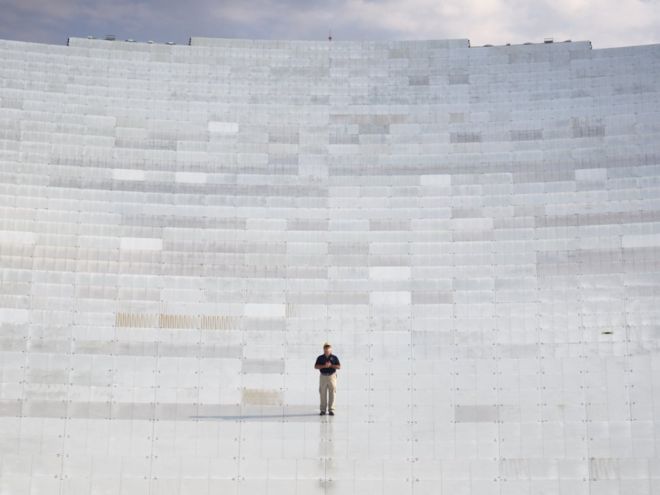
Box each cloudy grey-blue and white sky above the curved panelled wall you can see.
[0,0,660,48]
